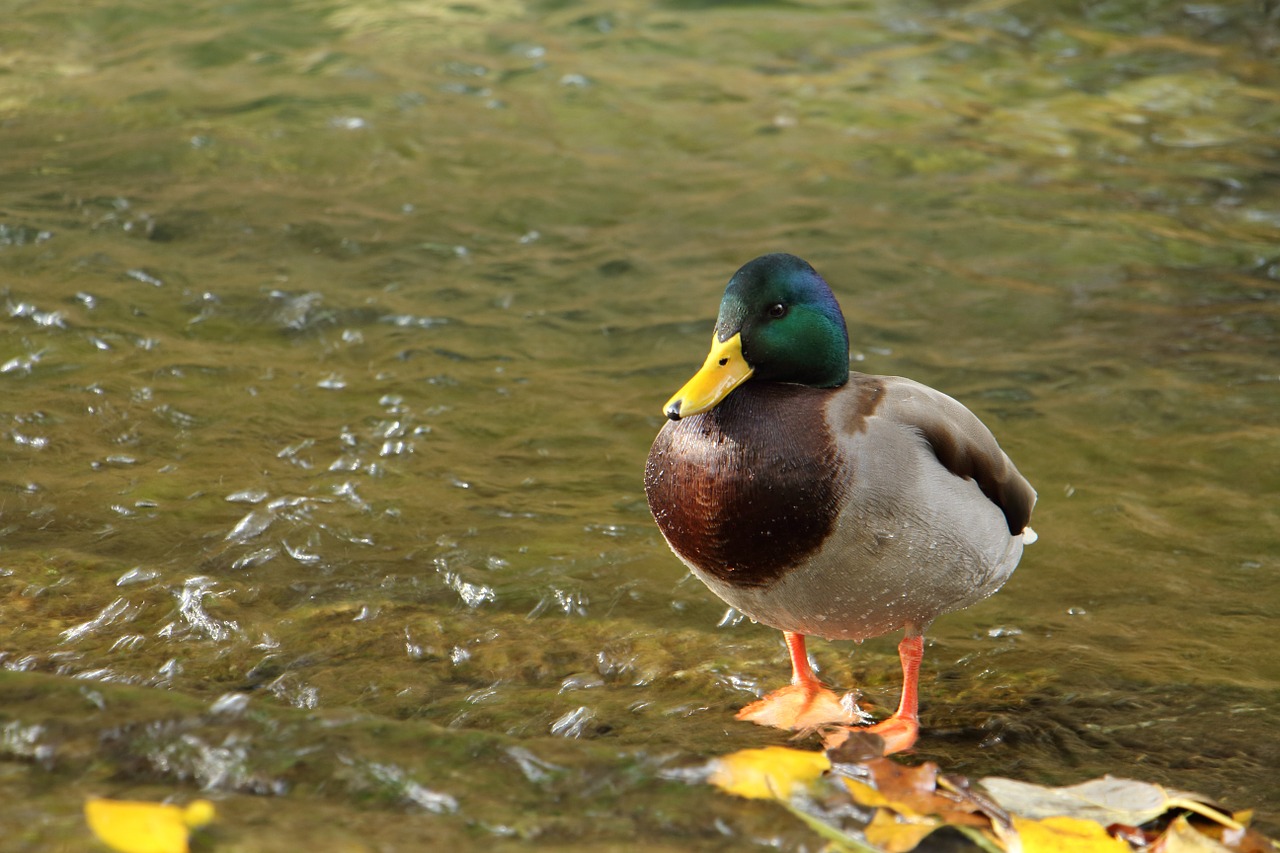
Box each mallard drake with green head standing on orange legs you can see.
[644,254,1036,753]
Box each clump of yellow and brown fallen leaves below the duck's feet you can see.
[707,747,1275,853]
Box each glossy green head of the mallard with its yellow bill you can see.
[663,254,849,420]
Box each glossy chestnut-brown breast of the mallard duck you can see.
[644,384,844,587]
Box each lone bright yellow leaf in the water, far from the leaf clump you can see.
[84,797,214,853]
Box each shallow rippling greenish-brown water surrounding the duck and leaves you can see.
[0,0,1280,850]
